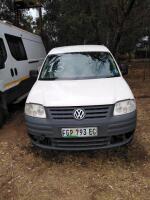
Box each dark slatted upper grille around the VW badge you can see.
[47,105,112,120]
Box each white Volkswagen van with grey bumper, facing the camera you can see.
[25,45,136,150]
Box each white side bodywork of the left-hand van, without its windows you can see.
[0,21,46,103]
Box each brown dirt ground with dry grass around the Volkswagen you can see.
[0,63,150,200]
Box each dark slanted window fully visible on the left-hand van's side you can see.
[5,34,27,61]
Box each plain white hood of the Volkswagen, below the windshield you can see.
[27,77,134,107]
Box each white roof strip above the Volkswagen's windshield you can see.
[49,45,110,55]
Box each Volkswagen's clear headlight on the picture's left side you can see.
[25,103,46,118]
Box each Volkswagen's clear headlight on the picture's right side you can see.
[114,100,136,115]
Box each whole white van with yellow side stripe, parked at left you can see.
[0,21,46,126]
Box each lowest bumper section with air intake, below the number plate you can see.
[30,131,134,151]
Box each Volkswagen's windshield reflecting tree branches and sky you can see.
[39,52,120,80]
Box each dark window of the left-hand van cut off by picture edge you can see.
[0,38,7,69]
